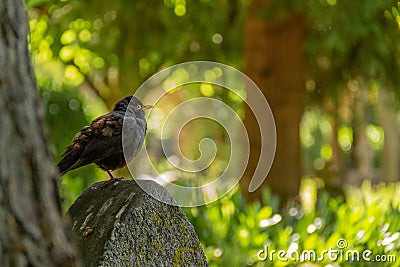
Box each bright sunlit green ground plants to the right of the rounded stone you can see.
[185,179,400,266]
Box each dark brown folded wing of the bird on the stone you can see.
[58,112,124,174]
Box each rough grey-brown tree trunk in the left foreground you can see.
[0,0,76,266]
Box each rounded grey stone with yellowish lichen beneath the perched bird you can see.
[68,180,207,266]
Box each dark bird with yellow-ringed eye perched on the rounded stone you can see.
[57,96,152,180]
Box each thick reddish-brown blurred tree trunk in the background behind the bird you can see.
[241,0,306,205]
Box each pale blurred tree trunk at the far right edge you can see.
[379,89,400,182]
